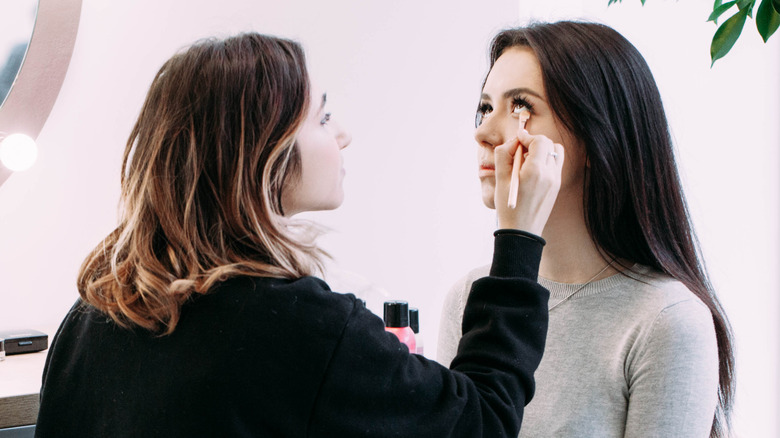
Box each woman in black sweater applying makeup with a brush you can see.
[36,33,563,438]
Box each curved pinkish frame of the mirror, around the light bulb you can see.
[0,0,81,185]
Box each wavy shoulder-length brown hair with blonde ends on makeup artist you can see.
[78,33,324,334]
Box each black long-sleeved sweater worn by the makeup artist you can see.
[36,235,548,438]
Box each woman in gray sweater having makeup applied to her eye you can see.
[438,22,734,438]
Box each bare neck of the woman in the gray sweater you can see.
[539,186,617,283]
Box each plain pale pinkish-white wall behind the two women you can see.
[0,0,780,437]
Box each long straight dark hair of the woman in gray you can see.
[490,21,734,437]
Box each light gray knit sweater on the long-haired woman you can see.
[437,265,718,438]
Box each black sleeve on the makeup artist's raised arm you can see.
[308,234,549,438]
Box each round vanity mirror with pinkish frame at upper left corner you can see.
[0,0,81,185]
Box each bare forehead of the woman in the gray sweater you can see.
[482,47,544,98]
